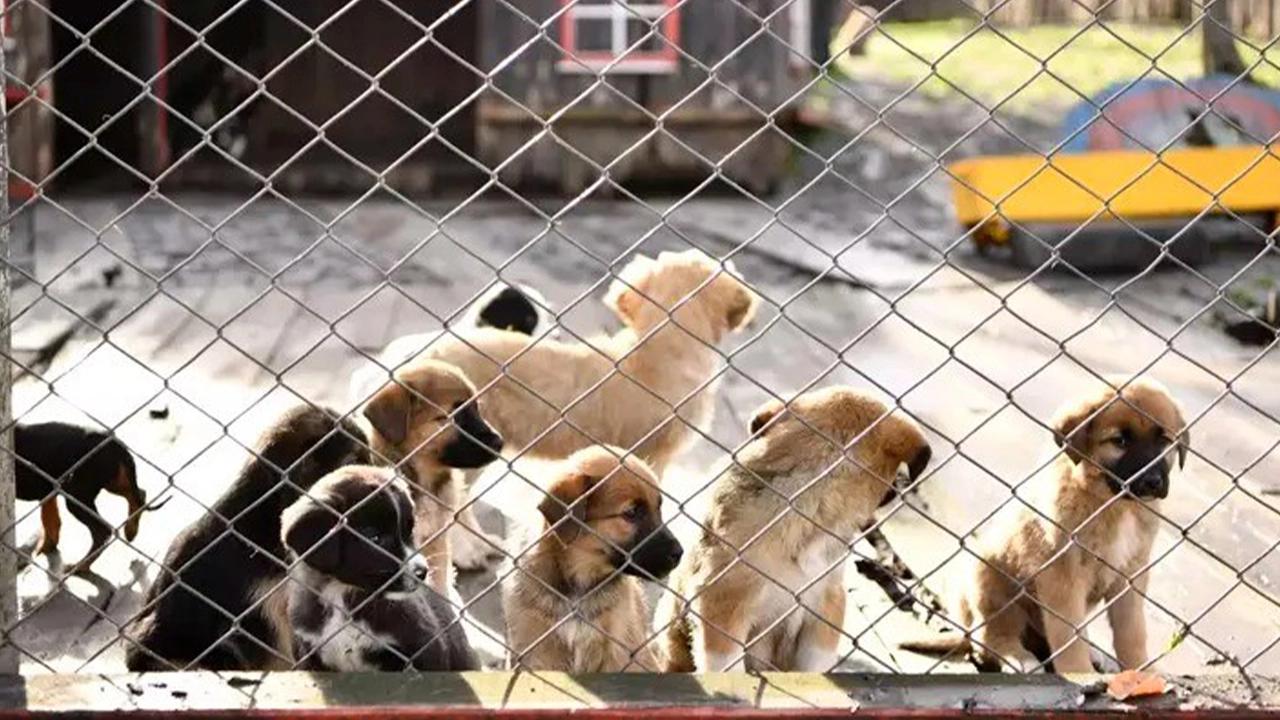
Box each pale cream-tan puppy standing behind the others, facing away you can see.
[399,250,758,568]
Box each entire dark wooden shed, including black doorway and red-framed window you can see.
[24,0,812,193]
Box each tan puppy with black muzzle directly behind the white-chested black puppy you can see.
[365,360,503,596]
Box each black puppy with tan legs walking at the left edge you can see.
[13,423,168,573]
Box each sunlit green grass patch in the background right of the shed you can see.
[832,20,1280,111]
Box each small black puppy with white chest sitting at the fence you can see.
[280,465,479,671]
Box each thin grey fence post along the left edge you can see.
[0,23,18,675]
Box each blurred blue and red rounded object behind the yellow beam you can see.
[1062,74,1280,152]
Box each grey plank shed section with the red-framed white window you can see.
[476,0,809,192]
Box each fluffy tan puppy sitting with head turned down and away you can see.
[655,387,931,673]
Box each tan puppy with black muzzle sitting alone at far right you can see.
[901,379,1190,673]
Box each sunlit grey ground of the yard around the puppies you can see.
[10,88,1280,674]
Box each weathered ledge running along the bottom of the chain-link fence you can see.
[0,673,1280,719]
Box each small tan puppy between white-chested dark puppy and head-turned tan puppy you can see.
[502,446,682,673]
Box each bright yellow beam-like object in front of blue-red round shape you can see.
[950,145,1280,243]
